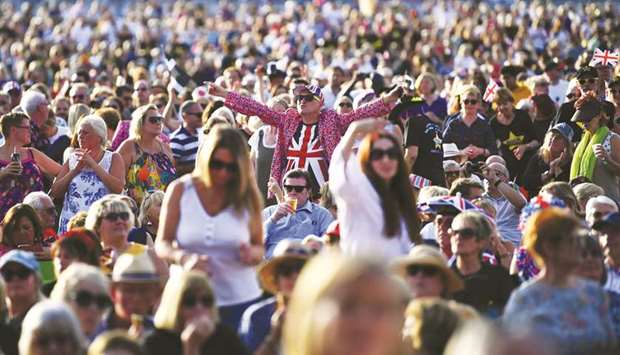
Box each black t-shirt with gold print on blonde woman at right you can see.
[491,109,536,181]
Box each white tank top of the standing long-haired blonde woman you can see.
[176,178,262,306]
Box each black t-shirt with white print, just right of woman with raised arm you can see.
[405,115,445,186]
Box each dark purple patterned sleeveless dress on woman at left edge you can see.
[0,149,43,221]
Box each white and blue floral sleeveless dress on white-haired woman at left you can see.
[58,150,114,234]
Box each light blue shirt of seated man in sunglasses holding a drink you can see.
[263,201,334,259]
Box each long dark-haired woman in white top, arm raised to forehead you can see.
[329,119,421,260]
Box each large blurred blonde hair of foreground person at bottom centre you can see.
[283,251,408,355]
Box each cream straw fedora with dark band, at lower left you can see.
[112,252,160,283]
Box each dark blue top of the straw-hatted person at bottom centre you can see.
[239,297,276,354]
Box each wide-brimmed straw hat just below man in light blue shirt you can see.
[258,239,313,294]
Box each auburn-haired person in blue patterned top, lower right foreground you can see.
[503,208,615,354]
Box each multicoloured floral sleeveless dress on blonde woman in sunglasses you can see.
[126,143,176,206]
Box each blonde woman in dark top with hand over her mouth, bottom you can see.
[144,271,247,355]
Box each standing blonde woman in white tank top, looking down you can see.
[155,128,263,330]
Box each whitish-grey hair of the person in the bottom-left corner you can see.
[18,300,86,354]
